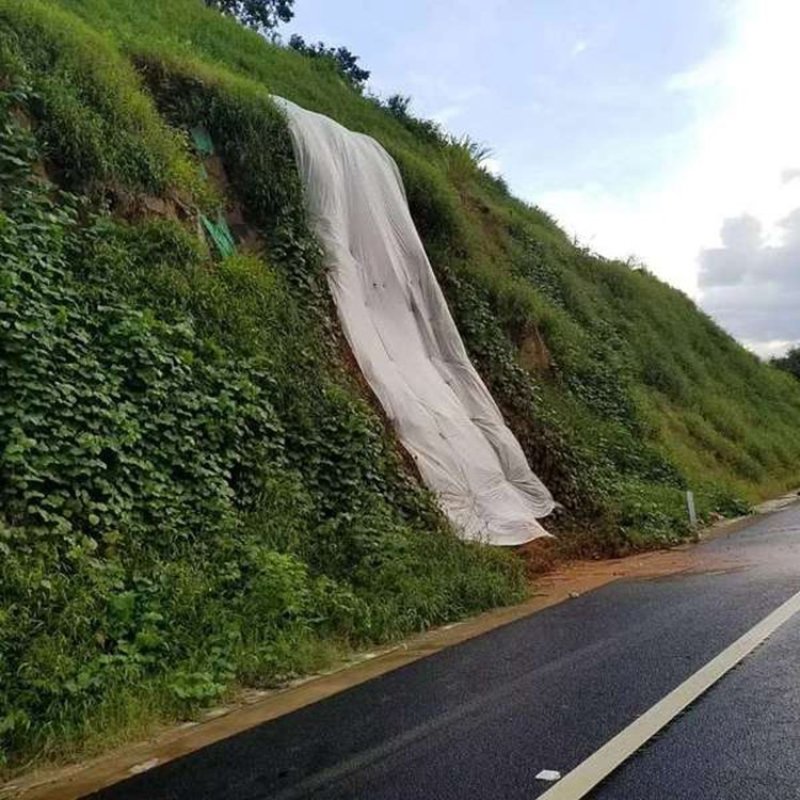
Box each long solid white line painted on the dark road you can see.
[539,592,800,800]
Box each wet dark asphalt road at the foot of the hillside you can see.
[93,505,800,800]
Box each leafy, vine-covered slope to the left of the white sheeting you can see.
[0,3,524,769]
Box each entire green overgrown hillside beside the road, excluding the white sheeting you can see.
[0,0,800,770]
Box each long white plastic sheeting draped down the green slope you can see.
[275,98,555,545]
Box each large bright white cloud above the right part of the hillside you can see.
[531,0,800,310]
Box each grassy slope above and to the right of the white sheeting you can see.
[36,0,800,523]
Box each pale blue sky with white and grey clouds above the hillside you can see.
[283,0,800,356]
